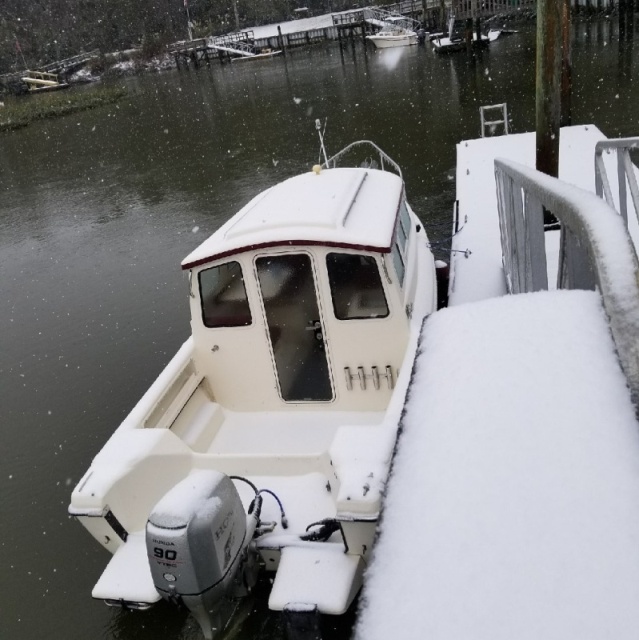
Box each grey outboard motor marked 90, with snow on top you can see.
[146,471,261,640]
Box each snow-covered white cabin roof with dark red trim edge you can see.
[182,168,403,269]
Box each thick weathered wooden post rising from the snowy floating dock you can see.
[536,0,562,177]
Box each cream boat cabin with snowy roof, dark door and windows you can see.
[183,169,415,411]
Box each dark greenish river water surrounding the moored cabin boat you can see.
[0,21,639,640]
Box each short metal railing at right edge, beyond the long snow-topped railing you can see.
[595,138,639,225]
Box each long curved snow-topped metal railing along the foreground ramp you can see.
[495,159,639,413]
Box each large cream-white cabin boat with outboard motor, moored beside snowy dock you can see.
[69,143,436,638]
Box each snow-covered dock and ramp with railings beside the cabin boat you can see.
[355,125,639,640]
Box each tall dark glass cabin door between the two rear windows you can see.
[255,253,333,402]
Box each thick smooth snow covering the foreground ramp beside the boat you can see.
[356,291,639,640]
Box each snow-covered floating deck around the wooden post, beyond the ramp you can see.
[449,125,639,306]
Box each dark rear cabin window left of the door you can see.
[199,262,252,328]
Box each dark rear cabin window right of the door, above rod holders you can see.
[326,253,388,320]
